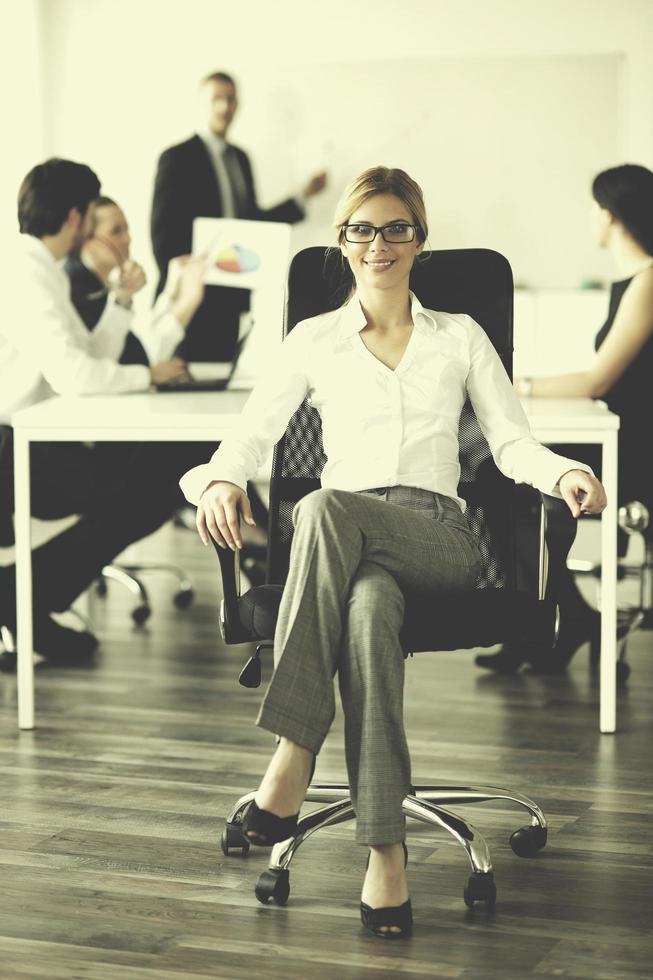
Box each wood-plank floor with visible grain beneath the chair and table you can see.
[0,528,653,980]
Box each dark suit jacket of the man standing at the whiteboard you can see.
[151,136,304,361]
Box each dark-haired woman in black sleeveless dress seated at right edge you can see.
[476,164,653,673]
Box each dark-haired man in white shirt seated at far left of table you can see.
[0,159,200,661]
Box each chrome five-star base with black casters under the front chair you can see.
[221,783,547,908]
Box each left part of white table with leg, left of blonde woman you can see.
[12,391,248,728]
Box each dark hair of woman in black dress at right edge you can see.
[592,163,653,255]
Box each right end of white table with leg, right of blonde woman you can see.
[522,398,619,732]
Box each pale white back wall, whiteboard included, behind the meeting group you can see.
[20,0,653,296]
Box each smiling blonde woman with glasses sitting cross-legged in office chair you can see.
[182,167,605,938]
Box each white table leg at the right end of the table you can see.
[599,432,618,733]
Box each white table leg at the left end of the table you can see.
[14,429,34,728]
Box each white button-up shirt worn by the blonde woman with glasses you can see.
[181,293,591,509]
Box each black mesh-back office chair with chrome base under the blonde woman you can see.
[209,248,576,907]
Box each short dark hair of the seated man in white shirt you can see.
[18,158,100,238]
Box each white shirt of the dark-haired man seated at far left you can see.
[0,235,150,423]
